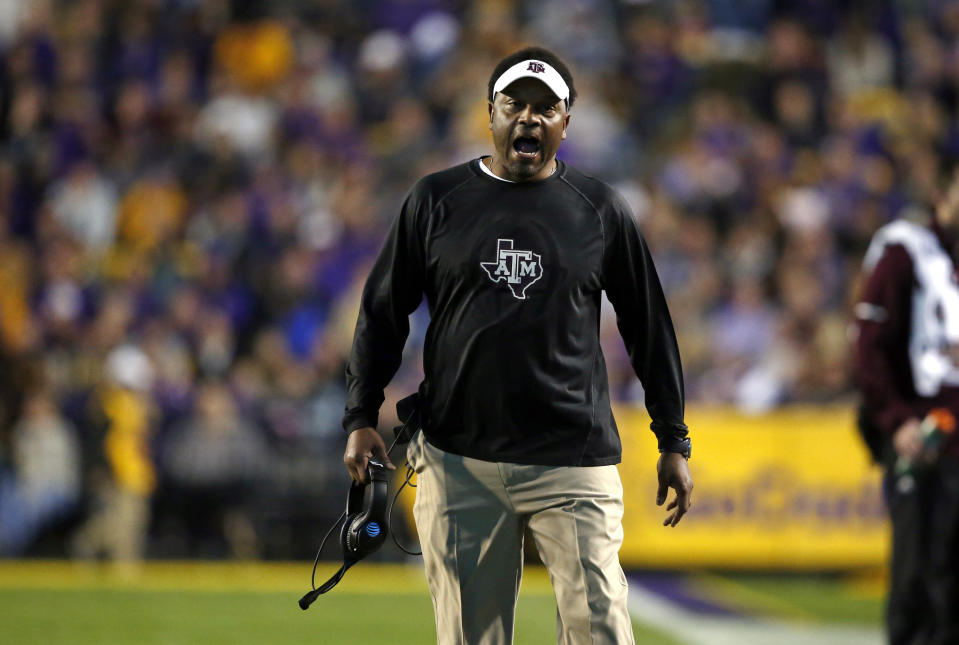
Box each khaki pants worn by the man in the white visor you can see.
[408,432,633,645]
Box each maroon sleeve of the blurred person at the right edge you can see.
[855,244,916,433]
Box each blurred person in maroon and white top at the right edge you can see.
[855,174,959,645]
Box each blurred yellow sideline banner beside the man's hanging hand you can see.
[615,406,889,570]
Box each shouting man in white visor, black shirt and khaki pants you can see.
[343,48,692,645]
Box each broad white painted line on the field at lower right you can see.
[629,581,883,645]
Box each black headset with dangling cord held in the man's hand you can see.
[299,394,420,611]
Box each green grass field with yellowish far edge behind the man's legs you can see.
[0,561,880,645]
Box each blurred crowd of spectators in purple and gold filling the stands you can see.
[0,0,959,560]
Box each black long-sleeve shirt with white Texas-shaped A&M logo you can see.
[343,160,687,465]
